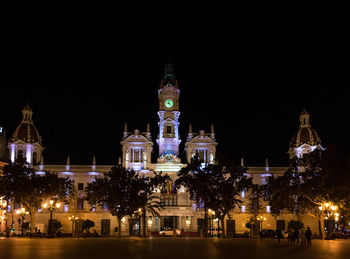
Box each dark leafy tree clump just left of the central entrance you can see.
[85,165,168,237]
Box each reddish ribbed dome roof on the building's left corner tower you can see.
[12,105,41,143]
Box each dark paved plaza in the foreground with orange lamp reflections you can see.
[0,237,350,259]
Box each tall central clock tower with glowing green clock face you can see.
[157,64,181,161]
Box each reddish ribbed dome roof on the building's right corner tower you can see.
[290,110,321,147]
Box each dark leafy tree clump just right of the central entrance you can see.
[175,154,251,237]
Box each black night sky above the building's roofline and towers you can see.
[0,1,350,166]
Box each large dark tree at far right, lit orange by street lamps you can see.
[264,147,350,237]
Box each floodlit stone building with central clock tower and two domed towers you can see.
[0,64,321,236]
